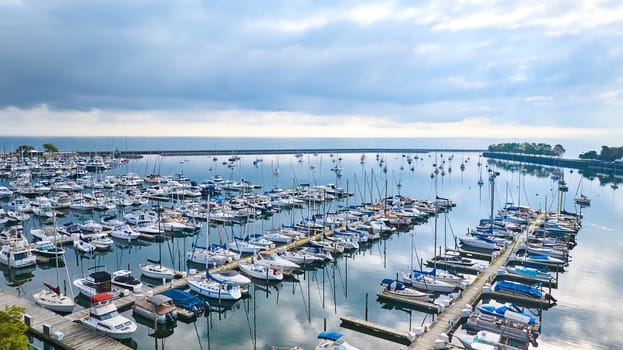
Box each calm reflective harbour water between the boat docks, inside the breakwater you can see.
[0,140,623,349]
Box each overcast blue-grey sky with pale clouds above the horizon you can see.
[0,0,623,143]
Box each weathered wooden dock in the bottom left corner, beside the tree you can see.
[0,290,131,350]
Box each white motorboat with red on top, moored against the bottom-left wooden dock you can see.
[78,293,138,339]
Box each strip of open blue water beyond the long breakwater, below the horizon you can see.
[0,136,603,158]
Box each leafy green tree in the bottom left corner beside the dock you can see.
[0,305,28,350]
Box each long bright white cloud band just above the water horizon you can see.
[0,105,611,138]
